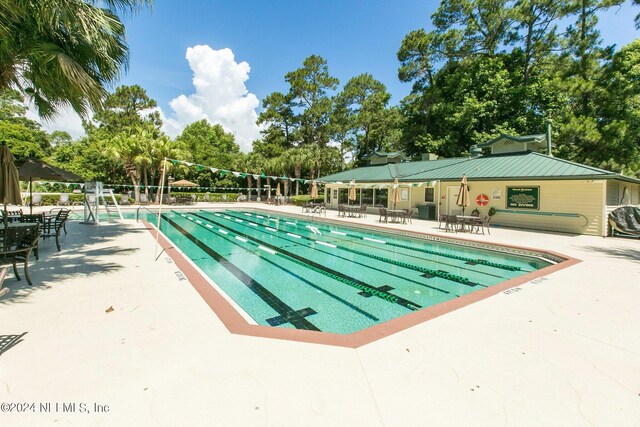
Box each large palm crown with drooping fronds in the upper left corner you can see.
[0,0,152,118]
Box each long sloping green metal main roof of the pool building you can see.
[319,151,640,183]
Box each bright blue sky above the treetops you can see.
[37,0,640,151]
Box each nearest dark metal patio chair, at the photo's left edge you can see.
[0,224,40,286]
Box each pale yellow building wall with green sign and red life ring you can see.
[439,180,606,236]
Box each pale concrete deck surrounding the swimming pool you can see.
[0,204,640,426]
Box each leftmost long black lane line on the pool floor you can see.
[162,215,320,331]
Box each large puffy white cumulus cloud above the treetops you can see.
[163,45,260,152]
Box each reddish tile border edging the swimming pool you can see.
[142,221,581,348]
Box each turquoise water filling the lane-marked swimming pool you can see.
[150,210,551,334]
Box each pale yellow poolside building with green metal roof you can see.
[319,140,640,236]
